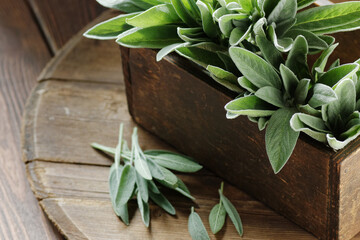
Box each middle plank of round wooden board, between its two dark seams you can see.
[23,80,171,165]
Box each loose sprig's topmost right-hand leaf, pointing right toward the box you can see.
[145,150,202,172]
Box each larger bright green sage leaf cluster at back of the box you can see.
[84,0,360,93]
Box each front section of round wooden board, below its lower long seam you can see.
[28,161,315,239]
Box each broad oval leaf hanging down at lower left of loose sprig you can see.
[115,164,136,206]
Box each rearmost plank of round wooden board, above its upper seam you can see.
[38,10,123,83]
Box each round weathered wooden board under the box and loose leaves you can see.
[22,11,360,239]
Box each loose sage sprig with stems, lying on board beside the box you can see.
[91,124,202,227]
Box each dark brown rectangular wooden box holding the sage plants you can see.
[121,30,360,239]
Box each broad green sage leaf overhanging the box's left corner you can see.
[116,25,181,48]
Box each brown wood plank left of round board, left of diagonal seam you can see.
[0,0,59,240]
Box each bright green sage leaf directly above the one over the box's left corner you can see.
[126,4,181,28]
